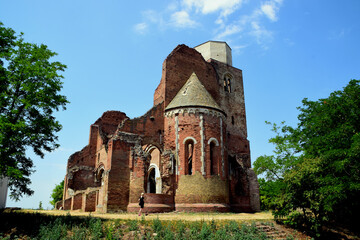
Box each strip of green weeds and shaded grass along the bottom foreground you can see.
[0,211,276,240]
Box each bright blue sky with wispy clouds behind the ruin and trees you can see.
[0,0,360,208]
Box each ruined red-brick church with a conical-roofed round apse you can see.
[57,41,260,213]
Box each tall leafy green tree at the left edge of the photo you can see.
[0,22,68,200]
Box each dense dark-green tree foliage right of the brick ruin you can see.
[254,80,360,231]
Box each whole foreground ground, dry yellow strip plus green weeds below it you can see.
[0,210,316,239]
